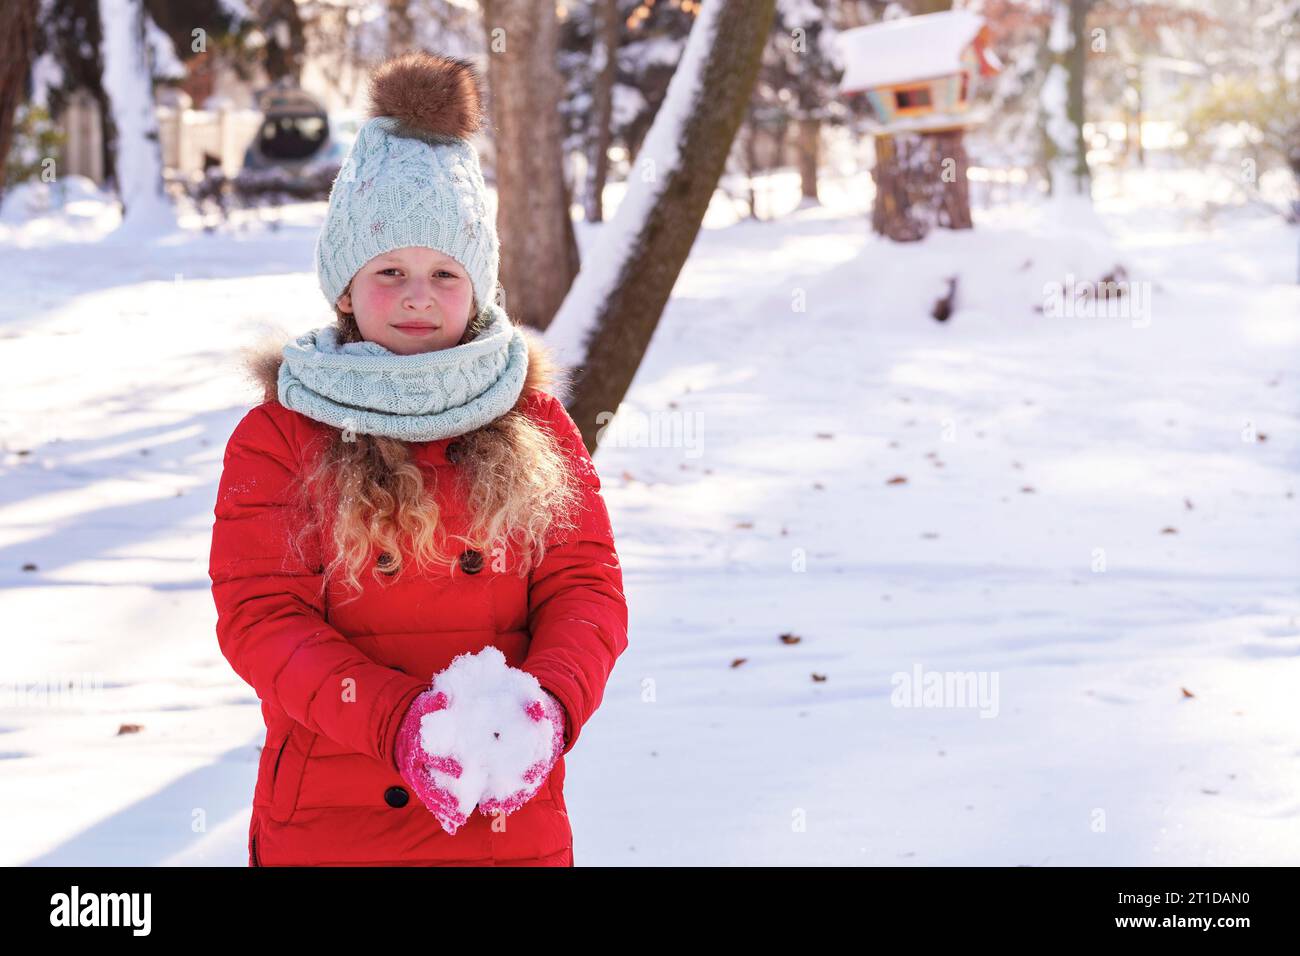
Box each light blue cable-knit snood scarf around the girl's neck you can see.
[277,303,528,441]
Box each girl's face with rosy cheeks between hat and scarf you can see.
[338,246,475,355]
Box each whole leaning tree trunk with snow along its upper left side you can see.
[546,0,776,451]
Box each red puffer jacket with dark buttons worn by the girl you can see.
[209,336,628,866]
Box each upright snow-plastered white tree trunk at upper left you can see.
[99,0,177,234]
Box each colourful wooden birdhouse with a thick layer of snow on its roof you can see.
[839,10,1002,133]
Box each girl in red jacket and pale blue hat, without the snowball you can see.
[209,52,628,866]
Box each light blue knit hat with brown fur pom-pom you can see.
[316,51,501,316]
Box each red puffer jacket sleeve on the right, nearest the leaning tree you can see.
[520,395,628,753]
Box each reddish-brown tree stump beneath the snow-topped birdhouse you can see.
[871,129,972,242]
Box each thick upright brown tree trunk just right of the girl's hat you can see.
[484,0,579,329]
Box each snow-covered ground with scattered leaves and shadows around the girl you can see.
[0,166,1300,865]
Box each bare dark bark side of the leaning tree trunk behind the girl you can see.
[567,0,776,451]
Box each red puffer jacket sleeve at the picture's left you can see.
[208,405,425,770]
